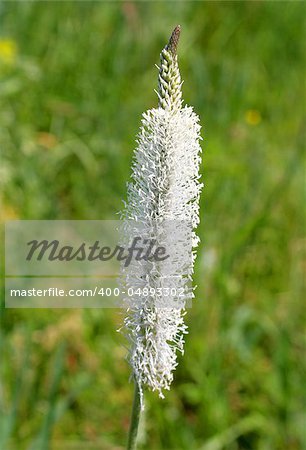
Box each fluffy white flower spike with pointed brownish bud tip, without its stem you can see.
[122,28,202,408]
